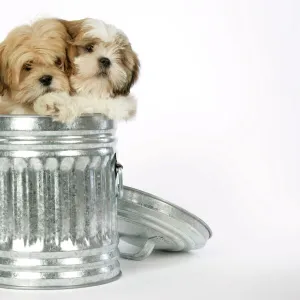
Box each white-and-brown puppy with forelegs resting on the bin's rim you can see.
[35,19,140,122]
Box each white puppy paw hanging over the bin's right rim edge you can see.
[106,96,137,121]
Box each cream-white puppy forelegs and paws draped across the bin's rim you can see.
[34,92,137,123]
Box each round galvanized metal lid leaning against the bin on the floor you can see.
[118,186,212,260]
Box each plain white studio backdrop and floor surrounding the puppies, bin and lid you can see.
[0,0,300,300]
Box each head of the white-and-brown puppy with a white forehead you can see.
[64,19,140,97]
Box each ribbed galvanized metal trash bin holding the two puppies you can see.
[0,115,122,289]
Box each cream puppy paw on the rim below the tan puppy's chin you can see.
[34,92,77,123]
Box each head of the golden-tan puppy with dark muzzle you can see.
[0,19,70,105]
